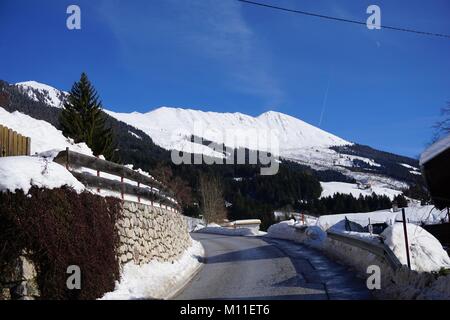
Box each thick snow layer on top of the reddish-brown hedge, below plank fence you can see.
[0,156,85,193]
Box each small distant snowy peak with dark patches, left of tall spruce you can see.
[15,81,67,108]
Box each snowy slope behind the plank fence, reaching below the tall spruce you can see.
[0,107,92,155]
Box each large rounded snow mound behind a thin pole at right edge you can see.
[381,223,450,272]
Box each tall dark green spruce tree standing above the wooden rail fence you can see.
[60,72,115,160]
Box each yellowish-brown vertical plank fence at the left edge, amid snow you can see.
[0,125,31,157]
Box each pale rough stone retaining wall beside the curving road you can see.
[117,201,192,265]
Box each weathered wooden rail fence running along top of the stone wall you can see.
[53,148,180,210]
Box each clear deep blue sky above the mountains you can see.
[0,0,450,157]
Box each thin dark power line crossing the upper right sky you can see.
[237,0,450,39]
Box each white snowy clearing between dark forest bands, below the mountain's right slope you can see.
[320,182,402,200]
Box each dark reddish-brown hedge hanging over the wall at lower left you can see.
[0,187,121,299]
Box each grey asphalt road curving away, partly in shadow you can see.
[175,233,371,300]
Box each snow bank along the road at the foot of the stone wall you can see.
[101,240,204,300]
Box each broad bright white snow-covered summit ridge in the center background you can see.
[108,107,351,154]
